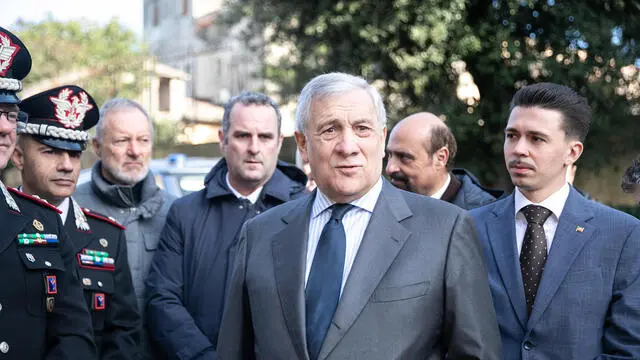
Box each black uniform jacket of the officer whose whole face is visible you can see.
[64,199,141,359]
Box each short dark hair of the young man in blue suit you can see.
[509,83,591,142]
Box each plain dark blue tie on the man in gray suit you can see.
[305,204,353,360]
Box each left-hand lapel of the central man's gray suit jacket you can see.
[272,195,315,359]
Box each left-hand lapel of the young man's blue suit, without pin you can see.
[487,195,527,329]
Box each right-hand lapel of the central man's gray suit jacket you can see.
[318,181,412,359]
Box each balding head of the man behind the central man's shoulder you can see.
[386,112,457,196]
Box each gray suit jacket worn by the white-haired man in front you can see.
[218,181,502,360]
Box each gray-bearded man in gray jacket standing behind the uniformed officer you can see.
[73,98,175,359]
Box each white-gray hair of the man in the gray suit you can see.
[296,72,387,134]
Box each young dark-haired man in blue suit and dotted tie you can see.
[471,83,640,360]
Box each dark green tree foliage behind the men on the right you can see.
[230,0,640,184]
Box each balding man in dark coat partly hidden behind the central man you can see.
[386,112,502,210]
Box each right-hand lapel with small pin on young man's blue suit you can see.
[528,188,595,328]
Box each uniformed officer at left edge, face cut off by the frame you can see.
[0,27,96,360]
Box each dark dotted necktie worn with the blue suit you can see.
[520,205,551,314]
